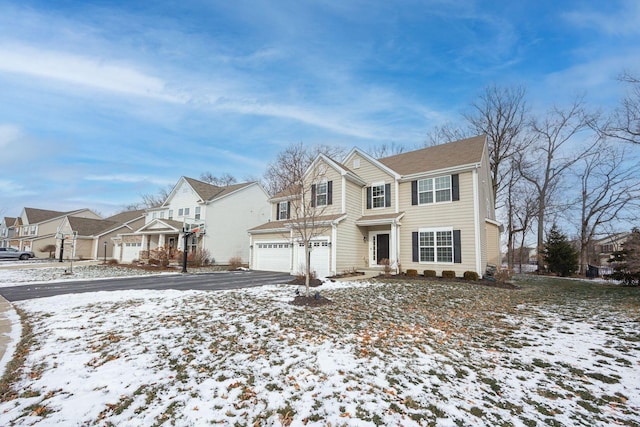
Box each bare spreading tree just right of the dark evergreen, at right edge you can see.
[577,141,640,274]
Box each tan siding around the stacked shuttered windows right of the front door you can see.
[400,172,480,276]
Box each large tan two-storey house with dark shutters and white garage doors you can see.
[249,136,501,276]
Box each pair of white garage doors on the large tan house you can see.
[254,239,331,277]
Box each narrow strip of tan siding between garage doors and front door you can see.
[334,180,367,274]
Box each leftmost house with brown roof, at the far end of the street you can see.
[11,208,101,257]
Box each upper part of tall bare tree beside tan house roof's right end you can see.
[464,85,528,205]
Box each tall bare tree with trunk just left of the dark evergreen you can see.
[516,98,595,267]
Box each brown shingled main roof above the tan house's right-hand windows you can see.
[378,135,487,175]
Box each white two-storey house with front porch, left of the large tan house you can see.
[114,177,270,263]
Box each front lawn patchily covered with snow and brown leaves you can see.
[0,277,640,426]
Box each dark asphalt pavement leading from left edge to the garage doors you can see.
[0,271,292,301]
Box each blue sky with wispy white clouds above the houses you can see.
[0,0,640,215]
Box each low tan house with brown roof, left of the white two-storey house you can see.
[56,210,146,259]
